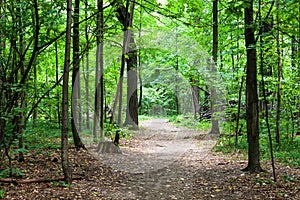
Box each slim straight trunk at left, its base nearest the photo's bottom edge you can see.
[61,0,72,184]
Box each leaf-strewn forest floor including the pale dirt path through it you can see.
[0,119,300,200]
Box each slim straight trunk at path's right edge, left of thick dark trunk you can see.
[210,0,220,134]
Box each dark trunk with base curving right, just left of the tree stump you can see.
[71,0,85,150]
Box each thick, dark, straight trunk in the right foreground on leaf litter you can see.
[244,0,262,172]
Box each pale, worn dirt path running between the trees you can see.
[95,119,216,200]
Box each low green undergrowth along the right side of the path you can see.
[168,115,300,167]
